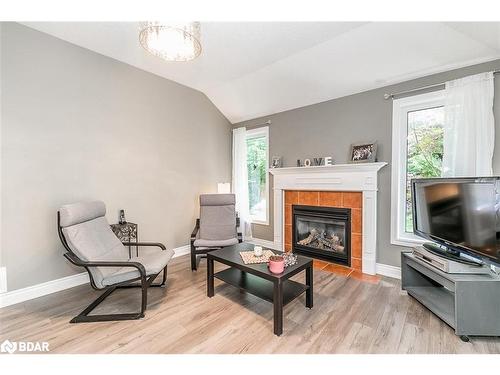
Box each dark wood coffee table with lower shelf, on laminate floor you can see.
[207,242,313,336]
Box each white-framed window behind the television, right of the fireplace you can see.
[391,91,444,246]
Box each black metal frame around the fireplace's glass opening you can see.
[292,204,352,267]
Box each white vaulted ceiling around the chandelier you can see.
[24,22,500,123]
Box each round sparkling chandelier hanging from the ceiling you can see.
[139,22,201,61]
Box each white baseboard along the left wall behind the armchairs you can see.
[0,245,191,308]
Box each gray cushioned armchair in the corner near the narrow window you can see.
[191,194,242,271]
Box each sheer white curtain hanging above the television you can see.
[443,72,495,177]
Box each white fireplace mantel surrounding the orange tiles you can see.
[269,162,387,275]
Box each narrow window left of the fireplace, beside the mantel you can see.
[247,126,269,225]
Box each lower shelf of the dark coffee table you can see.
[214,268,309,306]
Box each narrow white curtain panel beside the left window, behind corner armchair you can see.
[233,128,252,241]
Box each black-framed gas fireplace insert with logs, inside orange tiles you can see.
[292,205,351,266]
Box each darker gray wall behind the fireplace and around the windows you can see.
[235,60,500,266]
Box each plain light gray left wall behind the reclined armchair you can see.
[1,23,231,291]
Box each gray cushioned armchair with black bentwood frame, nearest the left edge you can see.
[57,201,174,323]
